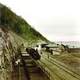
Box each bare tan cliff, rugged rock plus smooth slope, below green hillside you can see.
[0,25,25,80]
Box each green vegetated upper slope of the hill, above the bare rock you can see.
[0,4,48,44]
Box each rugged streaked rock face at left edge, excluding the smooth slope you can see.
[0,26,16,80]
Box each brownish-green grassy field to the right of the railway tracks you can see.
[53,53,80,74]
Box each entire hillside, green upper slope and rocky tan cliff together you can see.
[0,4,48,80]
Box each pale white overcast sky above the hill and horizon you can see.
[0,0,80,41]
